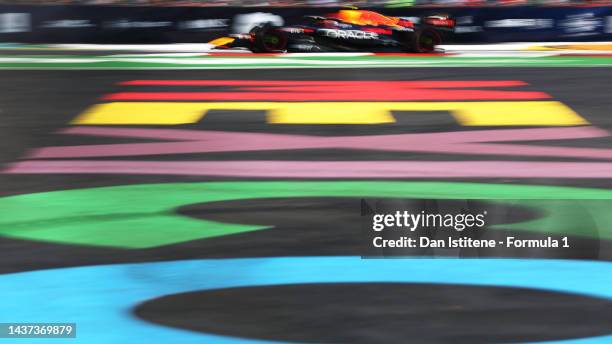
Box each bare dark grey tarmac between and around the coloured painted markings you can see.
[0,68,612,343]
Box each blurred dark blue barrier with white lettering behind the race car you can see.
[0,6,612,43]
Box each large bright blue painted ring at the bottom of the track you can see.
[0,257,612,344]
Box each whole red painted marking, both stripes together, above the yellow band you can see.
[113,80,550,101]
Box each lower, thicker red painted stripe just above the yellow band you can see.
[102,89,550,101]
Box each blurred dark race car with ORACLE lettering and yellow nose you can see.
[210,9,455,53]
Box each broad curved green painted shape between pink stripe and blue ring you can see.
[0,181,612,249]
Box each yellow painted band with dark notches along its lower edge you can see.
[72,101,589,126]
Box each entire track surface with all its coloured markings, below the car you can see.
[0,63,612,343]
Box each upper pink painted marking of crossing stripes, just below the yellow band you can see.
[28,127,612,159]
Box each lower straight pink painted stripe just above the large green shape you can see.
[3,160,612,179]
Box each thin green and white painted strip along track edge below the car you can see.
[0,54,612,69]
